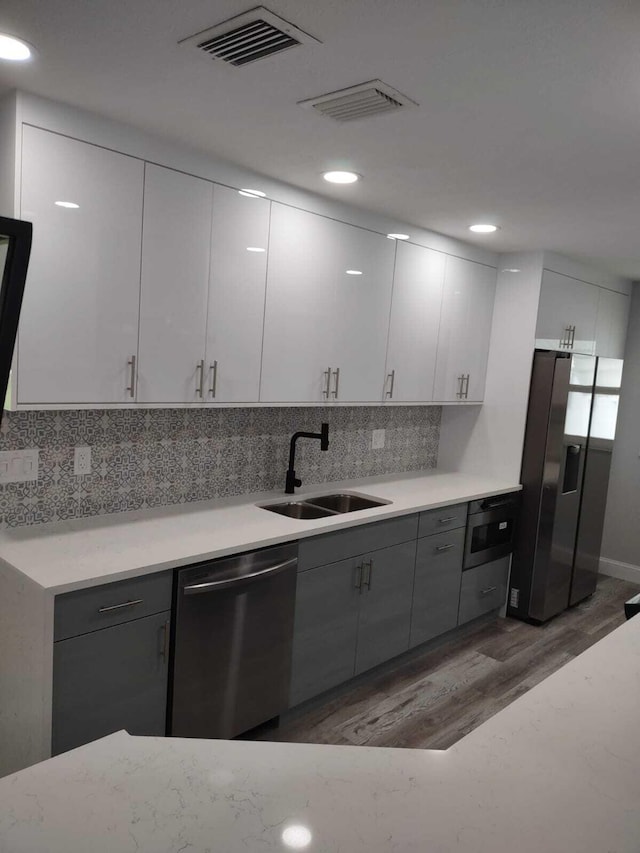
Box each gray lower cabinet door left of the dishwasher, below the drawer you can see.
[52,610,171,755]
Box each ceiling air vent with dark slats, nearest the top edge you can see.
[180,6,319,65]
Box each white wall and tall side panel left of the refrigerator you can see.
[438,252,543,483]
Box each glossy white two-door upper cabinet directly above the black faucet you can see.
[260,203,394,403]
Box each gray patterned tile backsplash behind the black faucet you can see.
[0,406,442,527]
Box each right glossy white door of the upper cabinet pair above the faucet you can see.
[326,222,395,403]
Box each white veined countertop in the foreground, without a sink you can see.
[0,604,640,853]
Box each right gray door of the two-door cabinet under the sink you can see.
[355,541,416,674]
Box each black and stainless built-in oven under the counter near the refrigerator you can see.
[462,492,520,571]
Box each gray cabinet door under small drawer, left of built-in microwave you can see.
[409,527,465,648]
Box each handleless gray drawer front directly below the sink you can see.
[298,515,418,571]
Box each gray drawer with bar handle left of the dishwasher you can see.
[53,571,173,641]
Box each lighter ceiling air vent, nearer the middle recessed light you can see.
[298,80,418,121]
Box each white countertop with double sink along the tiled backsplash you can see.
[0,470,520,594]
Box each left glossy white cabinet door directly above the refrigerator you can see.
[536,270,600,355]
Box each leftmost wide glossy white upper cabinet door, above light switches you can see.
[17,126,144,404]
